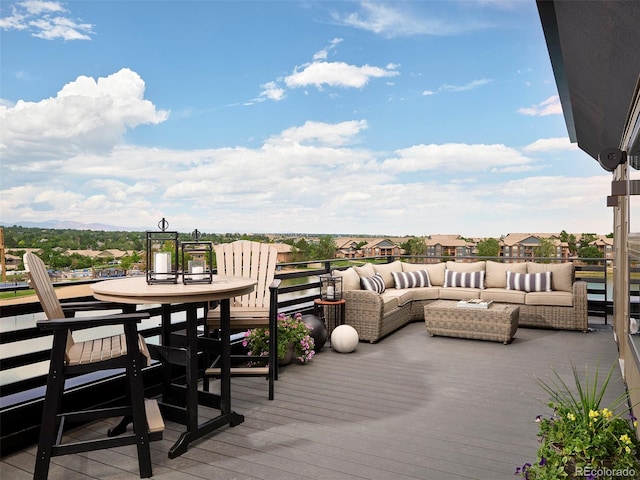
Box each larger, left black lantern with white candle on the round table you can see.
[147,218,178,285]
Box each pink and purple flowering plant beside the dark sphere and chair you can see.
[242,313,315,363]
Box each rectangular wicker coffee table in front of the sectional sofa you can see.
[424,300,520,345]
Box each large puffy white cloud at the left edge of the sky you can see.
[0,68,168,163]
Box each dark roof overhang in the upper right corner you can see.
[537,0,640,160]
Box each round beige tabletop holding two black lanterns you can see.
[91,275,257,304]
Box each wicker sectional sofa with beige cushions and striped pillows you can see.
[333,260,587,343]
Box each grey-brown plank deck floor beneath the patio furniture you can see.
[0,321,623,480]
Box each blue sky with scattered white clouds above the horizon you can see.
[0,0,612,236]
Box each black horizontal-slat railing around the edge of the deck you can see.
[0,256,608,456]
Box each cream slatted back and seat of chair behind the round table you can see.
[214,240,278,309]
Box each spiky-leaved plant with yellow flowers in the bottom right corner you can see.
[515,364,640,480]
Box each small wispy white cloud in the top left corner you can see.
[0,0,93,40]
